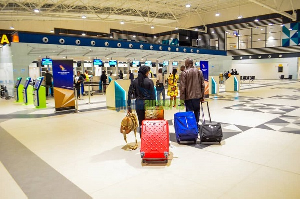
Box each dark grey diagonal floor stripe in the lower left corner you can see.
[0,127,91,199]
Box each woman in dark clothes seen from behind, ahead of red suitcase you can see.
[127,66,155,136]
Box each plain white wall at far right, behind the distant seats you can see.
[231,57,298,79]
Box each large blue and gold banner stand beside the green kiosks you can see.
[52,60,75,111]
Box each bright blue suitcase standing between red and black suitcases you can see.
[174,112,198,143]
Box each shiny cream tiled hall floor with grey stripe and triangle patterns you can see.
[0,80,300,199]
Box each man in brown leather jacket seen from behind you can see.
[180,59,205,123]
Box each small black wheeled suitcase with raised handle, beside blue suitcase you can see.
[199,101,223,143]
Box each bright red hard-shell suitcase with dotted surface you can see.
[141,120,169,162]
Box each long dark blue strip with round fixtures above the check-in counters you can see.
[18,32,227,56]
